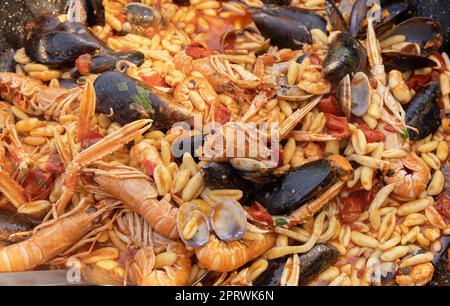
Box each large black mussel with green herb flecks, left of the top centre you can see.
[94,71,193,130]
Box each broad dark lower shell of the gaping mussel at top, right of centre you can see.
[252,10,312,50]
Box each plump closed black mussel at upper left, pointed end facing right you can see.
[25,31,98,65]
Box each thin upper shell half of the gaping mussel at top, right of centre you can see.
[264,6,327,33]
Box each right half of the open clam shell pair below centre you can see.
[211,198,247,241]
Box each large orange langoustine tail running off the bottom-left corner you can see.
[0,203,109,272]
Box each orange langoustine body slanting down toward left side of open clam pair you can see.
[84,162,178,239]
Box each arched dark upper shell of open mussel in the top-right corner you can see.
[378,17,443,56]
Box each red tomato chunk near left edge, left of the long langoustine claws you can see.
[23,170,53,201]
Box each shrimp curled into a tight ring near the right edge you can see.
[384,155,430,199]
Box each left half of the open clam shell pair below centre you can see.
[177,202,210,247]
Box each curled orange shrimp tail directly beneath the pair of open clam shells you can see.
[195,233,275,272]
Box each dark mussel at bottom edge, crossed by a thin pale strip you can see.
[253,243,339,286]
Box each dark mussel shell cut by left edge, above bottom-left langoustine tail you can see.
[0,210,34,243]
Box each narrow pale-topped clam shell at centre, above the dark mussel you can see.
[230,158,277,184]
